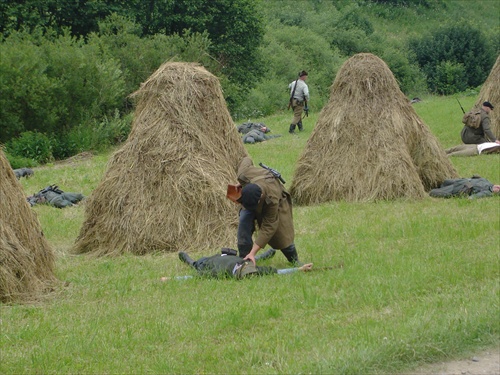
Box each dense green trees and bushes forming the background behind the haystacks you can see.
[0,0,500,164]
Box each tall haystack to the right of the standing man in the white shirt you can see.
[290,53,458,204]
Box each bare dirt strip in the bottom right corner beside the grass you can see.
[405,347,500,375]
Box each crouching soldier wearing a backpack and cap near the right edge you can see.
[461,101,500,144]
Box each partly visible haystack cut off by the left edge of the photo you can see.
[0,150,57,303]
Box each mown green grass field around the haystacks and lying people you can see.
[0,97,500,374]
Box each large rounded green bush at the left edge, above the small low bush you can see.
[0,28,125,141]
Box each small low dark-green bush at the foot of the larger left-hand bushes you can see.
[5,131,53,164]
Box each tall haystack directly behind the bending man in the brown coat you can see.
[74,63,247,256]
